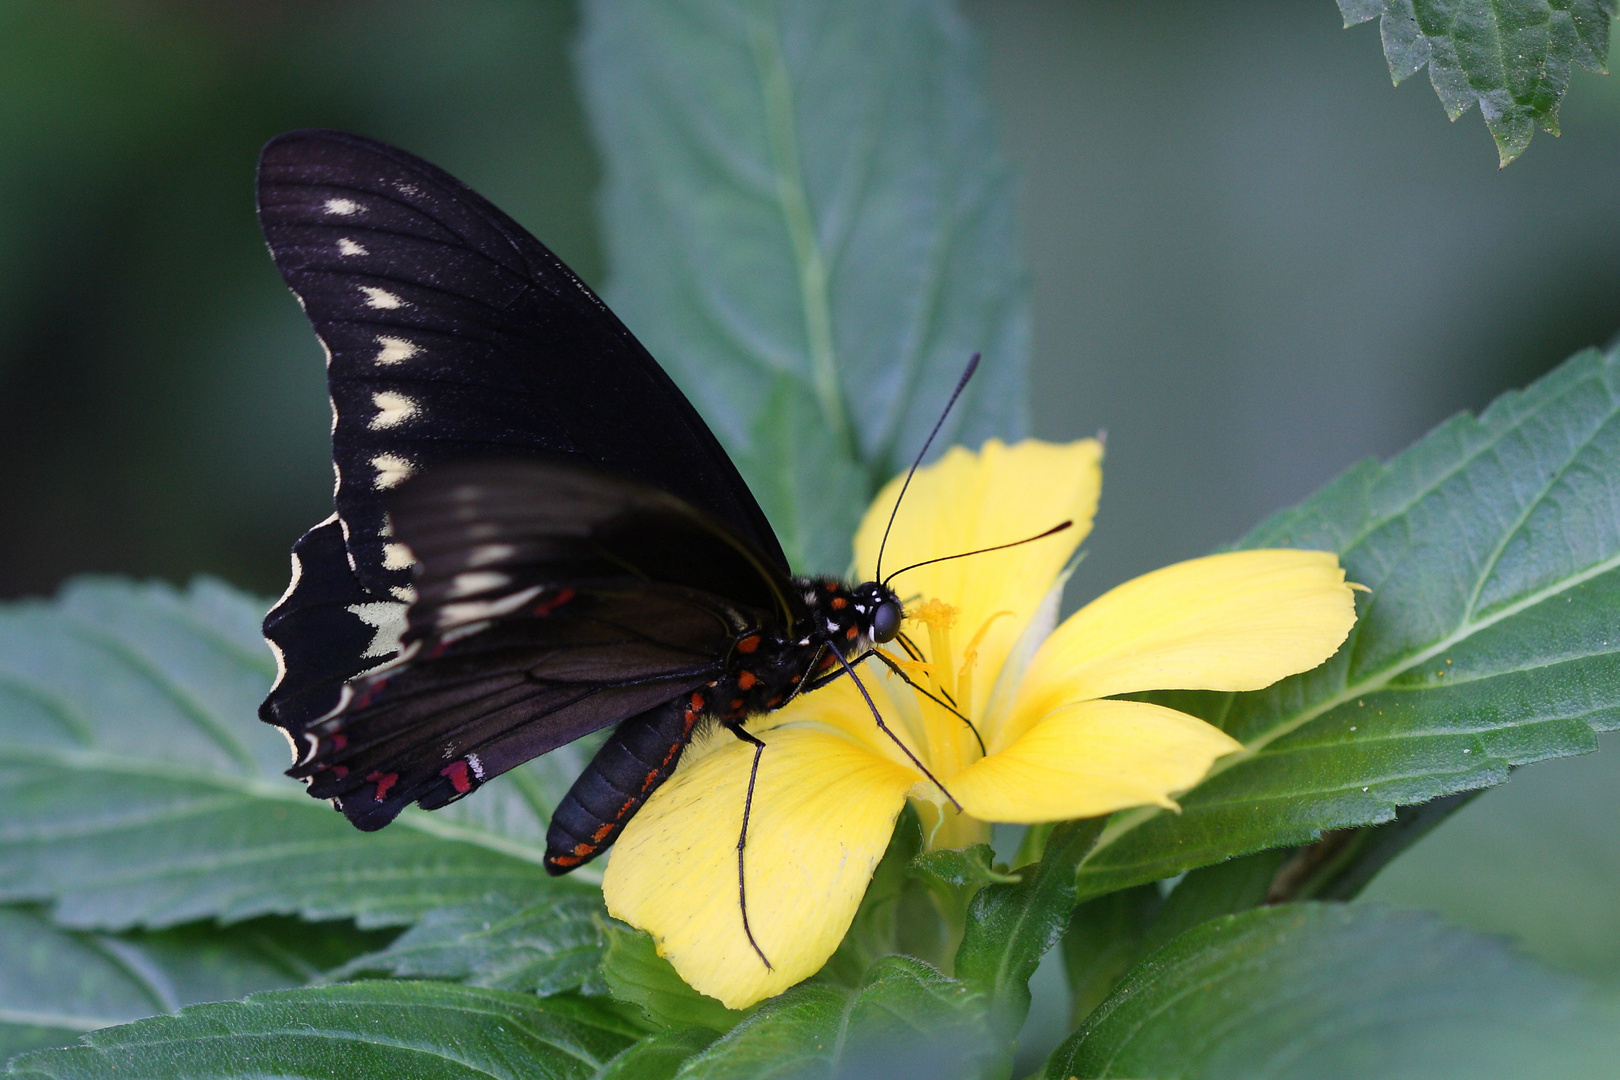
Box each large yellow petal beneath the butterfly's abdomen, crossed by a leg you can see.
[603,727,919,1009]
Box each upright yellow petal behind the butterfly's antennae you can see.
[855,439,1103,716]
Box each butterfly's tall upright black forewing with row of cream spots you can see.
[259,131,786,596]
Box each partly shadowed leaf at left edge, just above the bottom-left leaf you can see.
[0,907,379,1059]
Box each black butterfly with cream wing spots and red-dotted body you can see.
[259,131,1023,959]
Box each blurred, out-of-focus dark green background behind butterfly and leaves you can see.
[0,0,1620,1016]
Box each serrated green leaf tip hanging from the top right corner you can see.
[1338,0,1615,165]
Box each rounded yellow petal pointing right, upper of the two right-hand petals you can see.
[991,549,1356,750]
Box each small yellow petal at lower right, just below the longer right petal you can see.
[951,701,1243,824]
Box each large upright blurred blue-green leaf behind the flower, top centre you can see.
[580,0,1029,572]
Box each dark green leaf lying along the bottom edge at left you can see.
[11,981,640,1080]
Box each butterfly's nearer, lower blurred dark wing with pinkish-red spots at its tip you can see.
[293,461,799,827]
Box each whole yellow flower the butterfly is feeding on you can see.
[603,439,1356,1007]
